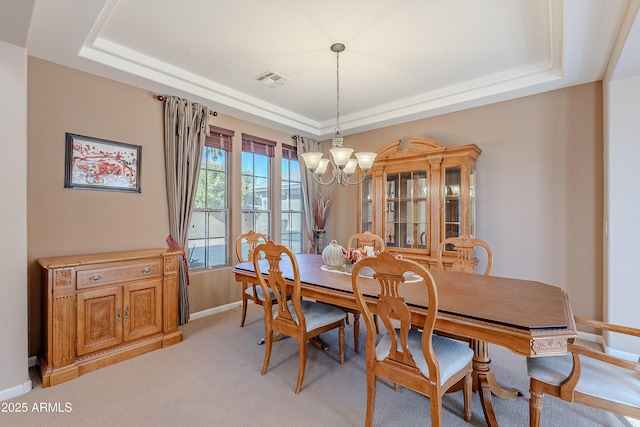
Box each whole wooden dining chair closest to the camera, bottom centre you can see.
[351,252,473,426]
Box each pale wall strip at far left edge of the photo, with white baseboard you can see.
[0,41,31,398]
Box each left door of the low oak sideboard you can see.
[76,287,122,356]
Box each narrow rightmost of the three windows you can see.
[281,144,304,254]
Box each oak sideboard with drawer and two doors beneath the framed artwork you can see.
[38,249,182,387]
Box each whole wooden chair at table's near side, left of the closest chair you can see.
[253,240,346,393]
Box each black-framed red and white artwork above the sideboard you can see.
[64,133,142,193]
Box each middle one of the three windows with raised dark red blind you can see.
[241,134,276,237]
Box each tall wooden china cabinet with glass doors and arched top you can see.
[358,138,482,268]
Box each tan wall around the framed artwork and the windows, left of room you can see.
[27,57,291,355]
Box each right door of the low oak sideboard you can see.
[124,280,162,341]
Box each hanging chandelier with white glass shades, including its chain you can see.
[301,43,376,187]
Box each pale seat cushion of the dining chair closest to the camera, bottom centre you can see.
[376,329,473,385]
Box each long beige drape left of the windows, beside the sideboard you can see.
[164,96,209,325]
